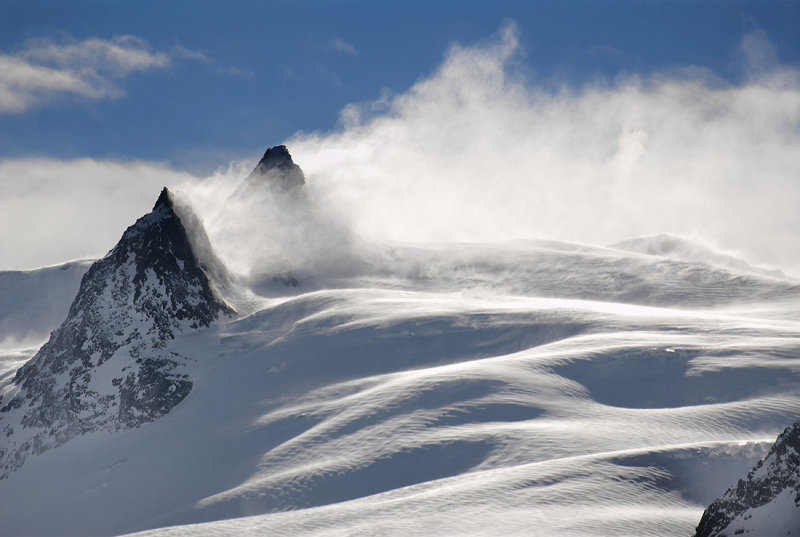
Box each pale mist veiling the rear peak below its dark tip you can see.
[197,165,358,291]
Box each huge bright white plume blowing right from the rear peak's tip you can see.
[289,24,800,270]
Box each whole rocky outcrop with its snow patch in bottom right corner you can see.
[695,421,800,537]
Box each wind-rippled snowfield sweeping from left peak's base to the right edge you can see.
[0,244,800,536]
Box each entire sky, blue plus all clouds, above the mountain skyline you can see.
[0,0,800,274]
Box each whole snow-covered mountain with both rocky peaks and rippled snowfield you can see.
[0,148,800,537]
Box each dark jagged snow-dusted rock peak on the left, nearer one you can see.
[0,188,231,477]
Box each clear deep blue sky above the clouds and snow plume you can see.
[0,1,800,172]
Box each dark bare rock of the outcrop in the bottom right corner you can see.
[695,421,800,537]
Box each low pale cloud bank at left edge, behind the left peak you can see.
[0,159,191,270]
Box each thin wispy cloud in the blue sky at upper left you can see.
[0,35,170,114]
